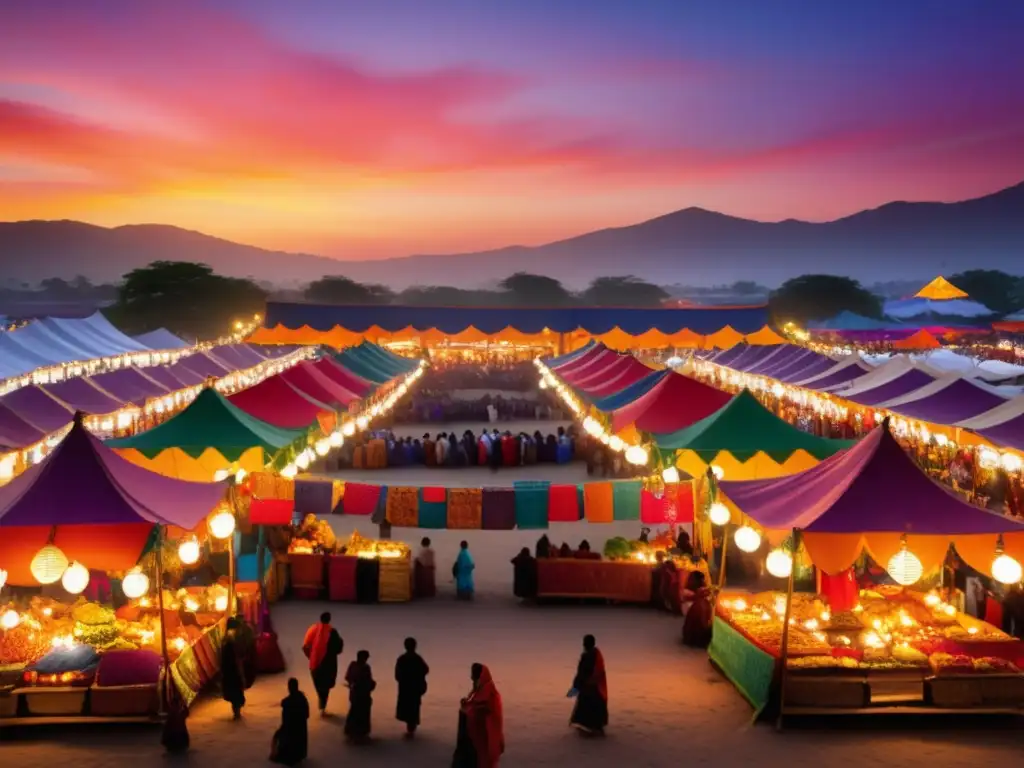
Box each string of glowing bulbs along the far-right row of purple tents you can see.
[671,359,1024,474]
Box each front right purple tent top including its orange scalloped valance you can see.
[719,422,1024,574]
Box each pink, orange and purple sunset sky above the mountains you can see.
[0,0,1024,259]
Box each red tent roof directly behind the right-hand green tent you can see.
[611,372,731,432]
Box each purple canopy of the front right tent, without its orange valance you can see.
[720,424,1024,536]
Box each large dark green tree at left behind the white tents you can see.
[110,261,266,339]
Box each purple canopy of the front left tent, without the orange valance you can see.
[0,421,226,529]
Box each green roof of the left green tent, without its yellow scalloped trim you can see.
[106,387,304,461]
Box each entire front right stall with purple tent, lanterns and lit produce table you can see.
[710,422,1024,721]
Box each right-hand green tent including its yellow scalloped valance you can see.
[654,389,853,480]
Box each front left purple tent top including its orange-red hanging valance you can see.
[0,418,226,586]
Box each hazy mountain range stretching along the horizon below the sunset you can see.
[0,182,1024,289]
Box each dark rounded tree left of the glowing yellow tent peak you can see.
[768,274,882,326]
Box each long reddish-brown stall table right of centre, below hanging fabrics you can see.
[537,558,651,603]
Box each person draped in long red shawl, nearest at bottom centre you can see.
[452,664,505,768]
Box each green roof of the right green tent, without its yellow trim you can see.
[654,389,854,463]
